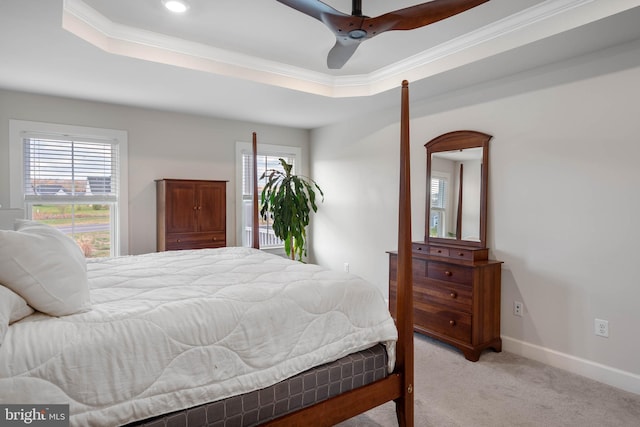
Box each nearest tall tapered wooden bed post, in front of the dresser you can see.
[396,80,414,427]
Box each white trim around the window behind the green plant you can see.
[235,141,304,248]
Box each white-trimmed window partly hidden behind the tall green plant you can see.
[236,142,301,248]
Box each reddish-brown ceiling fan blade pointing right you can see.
[364,0,489,35]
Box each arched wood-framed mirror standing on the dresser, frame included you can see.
[425,131,491,248]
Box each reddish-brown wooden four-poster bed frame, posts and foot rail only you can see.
[252,80,414,427]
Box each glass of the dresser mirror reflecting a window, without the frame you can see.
[429,147,483,242]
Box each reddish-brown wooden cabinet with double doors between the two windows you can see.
[156,179,227,251]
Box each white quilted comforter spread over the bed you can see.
[0,248,397,426]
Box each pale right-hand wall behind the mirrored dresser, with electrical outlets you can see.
[311,43,640,393]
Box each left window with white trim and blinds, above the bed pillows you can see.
[10,120,127,257]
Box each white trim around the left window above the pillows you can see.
[9,119,129,255]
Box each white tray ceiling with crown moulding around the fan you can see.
[0,0,640,128]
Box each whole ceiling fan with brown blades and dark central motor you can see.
[278,0,489,69]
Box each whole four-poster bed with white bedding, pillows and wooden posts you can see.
[0,82,413,426]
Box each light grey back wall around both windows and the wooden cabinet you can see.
[0,90,309,254]
